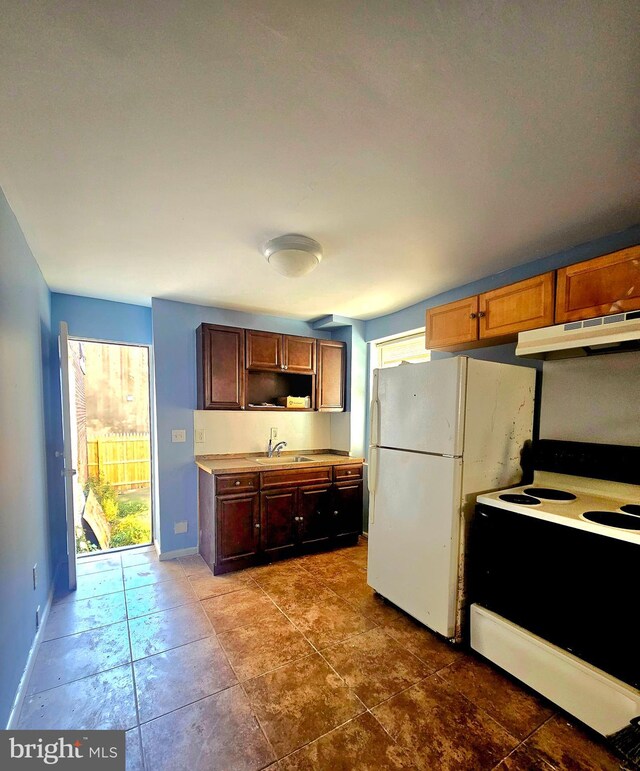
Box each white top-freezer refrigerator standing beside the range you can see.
[367,356,535,640]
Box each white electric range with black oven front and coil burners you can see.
[468,440,640,736]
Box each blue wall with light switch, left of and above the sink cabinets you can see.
[151,298,330,552]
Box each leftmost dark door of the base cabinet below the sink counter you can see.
[216,493,260,568]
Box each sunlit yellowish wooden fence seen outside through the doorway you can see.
[87,434,151,492]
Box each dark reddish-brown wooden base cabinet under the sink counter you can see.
[199,464,362,574]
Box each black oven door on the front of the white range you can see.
[469,505,640,688]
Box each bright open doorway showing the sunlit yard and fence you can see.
[68,339,153,557]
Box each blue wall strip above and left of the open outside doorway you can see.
[49,292,152,562]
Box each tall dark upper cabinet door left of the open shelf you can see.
[196,324,245,410]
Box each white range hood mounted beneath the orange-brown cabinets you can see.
[516,311,640,359]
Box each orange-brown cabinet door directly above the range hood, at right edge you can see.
[555,246,640,324]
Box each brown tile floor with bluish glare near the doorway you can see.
[19,540,620,771]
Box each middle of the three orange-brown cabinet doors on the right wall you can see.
[478,272,554,339]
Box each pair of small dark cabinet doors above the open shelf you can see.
[247,329,316,375]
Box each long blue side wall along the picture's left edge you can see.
[0,190,53,726]
